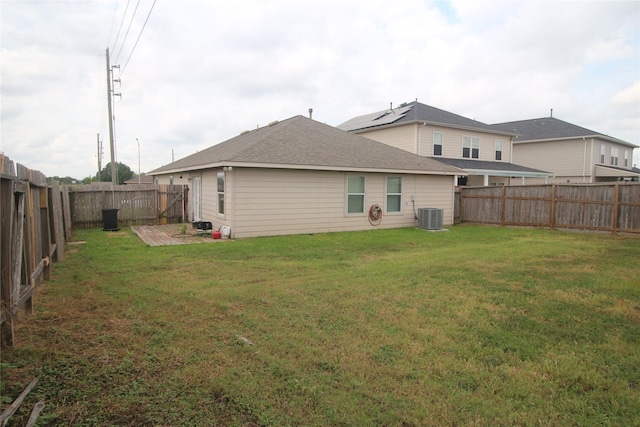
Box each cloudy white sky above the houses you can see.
[0,0,640,179]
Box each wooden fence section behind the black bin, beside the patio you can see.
[69,183,189,228]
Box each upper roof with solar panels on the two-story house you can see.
[337,101,513,135]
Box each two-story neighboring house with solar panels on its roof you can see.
[337,101,552,186]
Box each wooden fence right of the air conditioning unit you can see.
[455,182,640,234]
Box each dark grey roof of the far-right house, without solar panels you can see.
[491,117,636,147]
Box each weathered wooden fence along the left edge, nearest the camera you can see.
[0,154,71,346]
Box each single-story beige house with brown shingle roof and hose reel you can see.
[148,116,465,238]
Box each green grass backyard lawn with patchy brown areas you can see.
[2,225,640,426]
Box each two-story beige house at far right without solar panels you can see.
[491,117,640,183]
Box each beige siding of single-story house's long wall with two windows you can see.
[230,168,453,238]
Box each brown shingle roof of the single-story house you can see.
[148,116,466,175]
